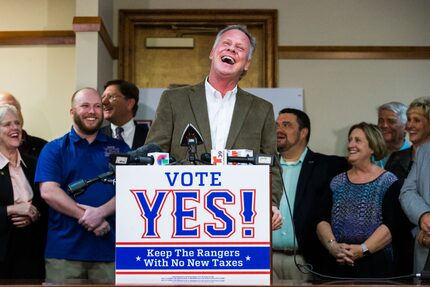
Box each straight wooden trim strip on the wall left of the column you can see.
[0,31,75,45]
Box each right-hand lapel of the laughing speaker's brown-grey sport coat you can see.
[225,87,252,149]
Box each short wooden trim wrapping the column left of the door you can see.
[73,17,118,60]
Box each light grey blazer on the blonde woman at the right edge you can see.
[399,142,430,272]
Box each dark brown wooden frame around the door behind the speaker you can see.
[118,9,278,87]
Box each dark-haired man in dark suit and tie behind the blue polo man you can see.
[101,80,148,149]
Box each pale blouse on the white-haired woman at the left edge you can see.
[0,151,33,203]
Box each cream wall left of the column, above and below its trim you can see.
[0,0,75,140]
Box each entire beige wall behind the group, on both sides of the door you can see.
[0,0,430,154]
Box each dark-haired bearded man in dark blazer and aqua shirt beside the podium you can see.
[272,108,348,282]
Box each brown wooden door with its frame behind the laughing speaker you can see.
[118,9,278,87]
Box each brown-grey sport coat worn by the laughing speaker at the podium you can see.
[146,82,282,206]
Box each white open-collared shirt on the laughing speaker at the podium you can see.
[205,78,237,150]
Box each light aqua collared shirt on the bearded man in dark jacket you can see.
[272,148,308,250]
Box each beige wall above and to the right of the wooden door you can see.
[114,0,430,154]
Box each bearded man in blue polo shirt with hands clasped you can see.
[35,88,129,283]
